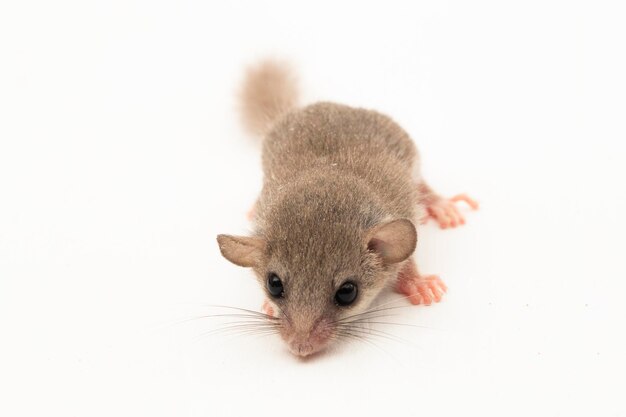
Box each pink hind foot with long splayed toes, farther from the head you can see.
[417,182,478,229]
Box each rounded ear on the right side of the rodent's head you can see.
[367,219,417,265]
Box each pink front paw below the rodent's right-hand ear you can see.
[396,257,448,305]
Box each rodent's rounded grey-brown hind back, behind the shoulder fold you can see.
[263,103,417,218]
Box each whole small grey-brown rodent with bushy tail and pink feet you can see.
[217,61,478,356]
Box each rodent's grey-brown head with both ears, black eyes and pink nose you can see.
[217,216,417,356]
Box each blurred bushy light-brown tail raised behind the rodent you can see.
[241,60,298,136]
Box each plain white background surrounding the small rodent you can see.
[0,0,626,417]
